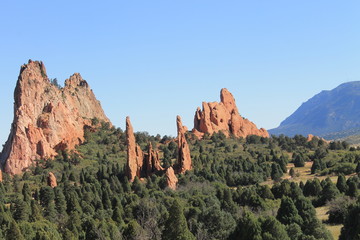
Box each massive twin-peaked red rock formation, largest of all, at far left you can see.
[0,60,110,174]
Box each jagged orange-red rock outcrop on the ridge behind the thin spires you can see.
[193,88,269,138]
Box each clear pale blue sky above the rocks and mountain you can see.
[0,0,360,143]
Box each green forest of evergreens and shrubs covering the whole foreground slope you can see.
[0,124,360,240]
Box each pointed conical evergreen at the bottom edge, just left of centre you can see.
[163,199,195,240]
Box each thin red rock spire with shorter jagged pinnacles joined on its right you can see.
[126,117,164,181]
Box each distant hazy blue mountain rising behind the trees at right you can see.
[269,81,360,138]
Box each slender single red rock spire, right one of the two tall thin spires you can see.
[176,116,192,173]
